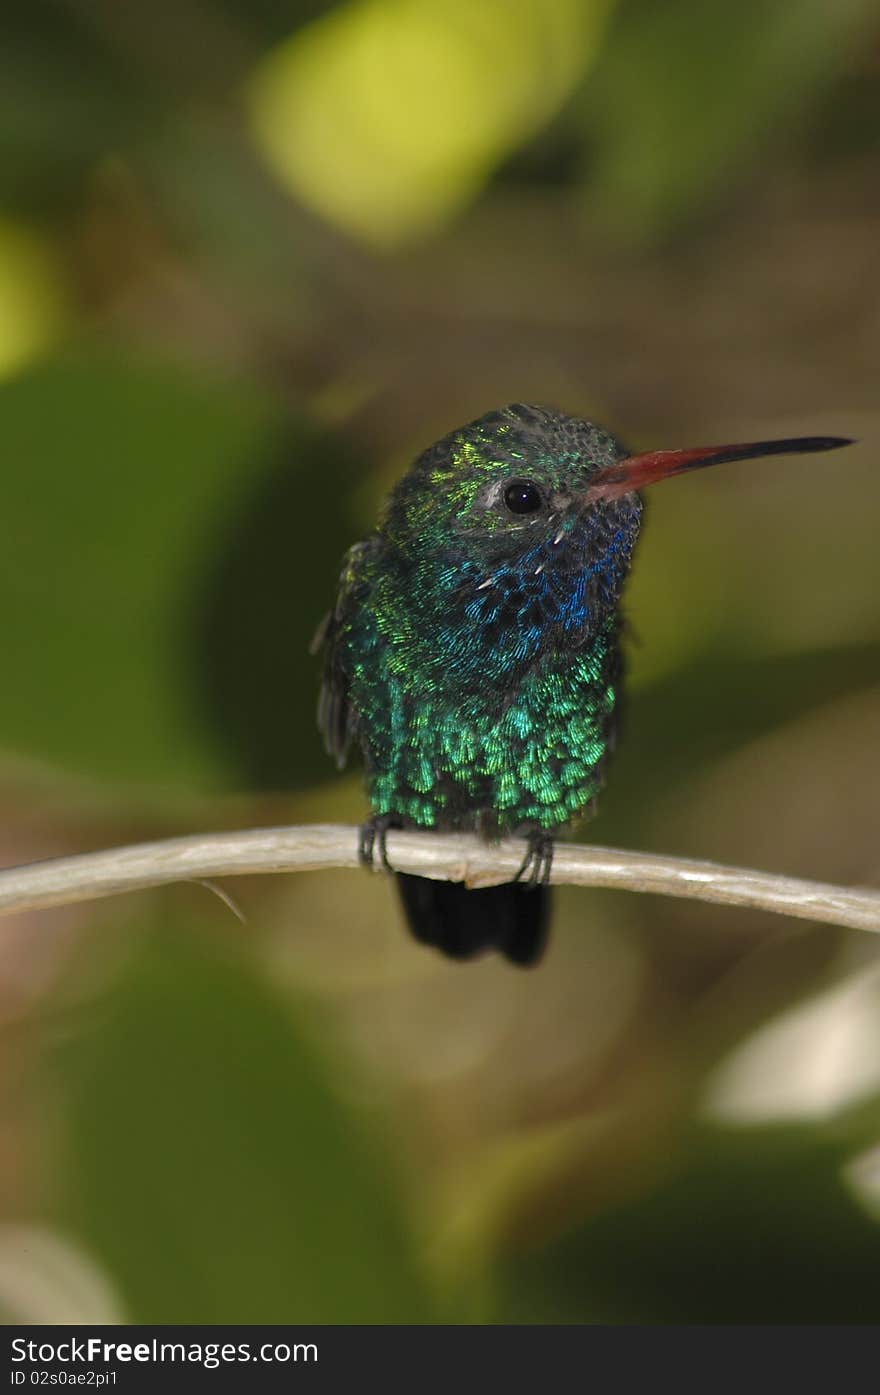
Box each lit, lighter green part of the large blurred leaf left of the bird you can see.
[0,360,279,785]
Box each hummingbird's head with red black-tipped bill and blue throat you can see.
[382,403,847,669]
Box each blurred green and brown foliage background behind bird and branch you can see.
[0,0,880,1322]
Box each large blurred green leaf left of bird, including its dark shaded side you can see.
[0,351,365,792]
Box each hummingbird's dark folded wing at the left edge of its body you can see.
[311,534,381,770]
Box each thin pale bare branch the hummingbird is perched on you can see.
[0,823,880,932]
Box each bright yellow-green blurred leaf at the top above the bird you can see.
[247,0,609,248]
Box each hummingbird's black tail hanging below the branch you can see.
[395,872,549,968]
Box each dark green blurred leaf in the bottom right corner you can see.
[498,1110,880,1324]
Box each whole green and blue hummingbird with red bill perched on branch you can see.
[317,403,849,965]
